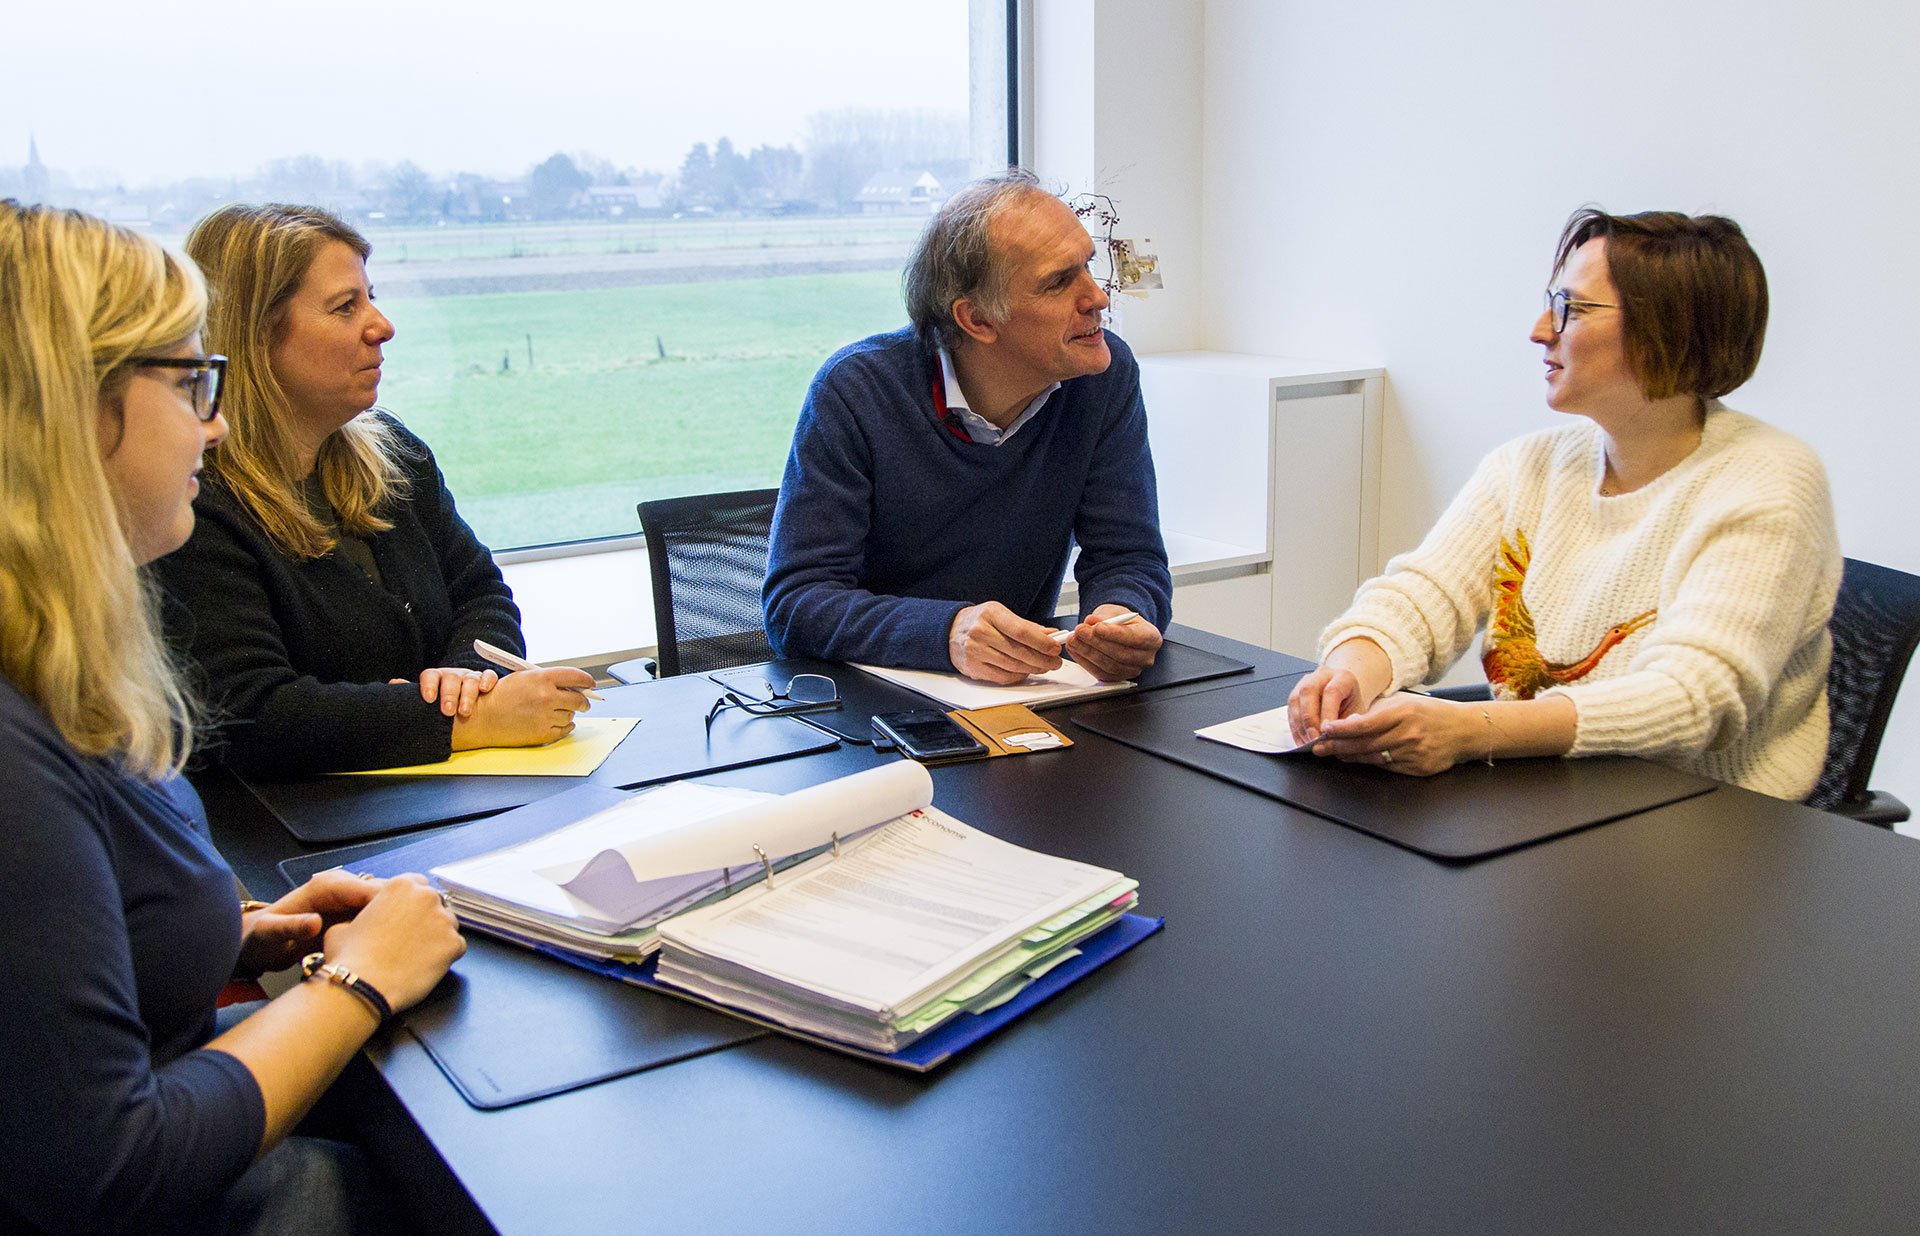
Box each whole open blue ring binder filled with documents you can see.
[430,760,1158,1067]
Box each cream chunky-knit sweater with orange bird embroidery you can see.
[1321,401,1841,798]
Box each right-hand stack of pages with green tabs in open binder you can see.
[657,802,1139,1054]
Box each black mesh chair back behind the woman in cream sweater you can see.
[1807,559,1920,808]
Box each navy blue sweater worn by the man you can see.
[764,330,1173,670]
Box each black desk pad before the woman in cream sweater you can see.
[1073,676,1715,862]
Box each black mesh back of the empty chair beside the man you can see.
[639,489,780,677]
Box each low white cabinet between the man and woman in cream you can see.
[1140,351,1384,656]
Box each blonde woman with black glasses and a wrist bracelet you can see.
[0,202,465,1232]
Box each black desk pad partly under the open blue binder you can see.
[280,820,766,1109]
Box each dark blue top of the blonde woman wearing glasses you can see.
[0,676,267,1232]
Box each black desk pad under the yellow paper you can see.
[242,676,835,844]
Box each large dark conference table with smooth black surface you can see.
[198,631,1920,1236]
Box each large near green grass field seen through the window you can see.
[380,273,906,549]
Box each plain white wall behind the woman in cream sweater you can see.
[1035,0,1920,829]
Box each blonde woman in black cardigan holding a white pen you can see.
[159,205,593,773]
